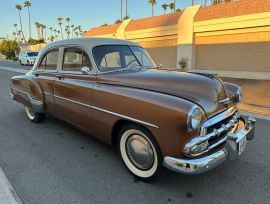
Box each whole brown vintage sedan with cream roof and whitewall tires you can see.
[10,38,256,181]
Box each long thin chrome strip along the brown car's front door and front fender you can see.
[54,95,159,128]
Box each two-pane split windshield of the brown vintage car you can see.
[93,45,155,72]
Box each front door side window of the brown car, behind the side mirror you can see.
[63,48,92,72]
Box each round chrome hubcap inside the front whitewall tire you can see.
[126,135,154,170]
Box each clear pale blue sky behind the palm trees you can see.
[0,0,207,37]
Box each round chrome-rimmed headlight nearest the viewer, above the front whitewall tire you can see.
[187,106,202,131]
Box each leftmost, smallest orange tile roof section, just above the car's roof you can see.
[84,23,121,37]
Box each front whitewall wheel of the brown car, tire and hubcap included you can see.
[118,124,163,182]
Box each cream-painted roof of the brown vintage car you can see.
[43,37,139,50]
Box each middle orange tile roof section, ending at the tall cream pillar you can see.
[126,12,182,31]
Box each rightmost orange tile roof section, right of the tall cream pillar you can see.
[195,0,270,21]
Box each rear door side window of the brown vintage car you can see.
[38,50,59,70]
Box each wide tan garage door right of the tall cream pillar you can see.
[196,42,270,71]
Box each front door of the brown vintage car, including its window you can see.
[54,47,96,132]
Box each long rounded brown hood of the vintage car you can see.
[99,69,231,117]
